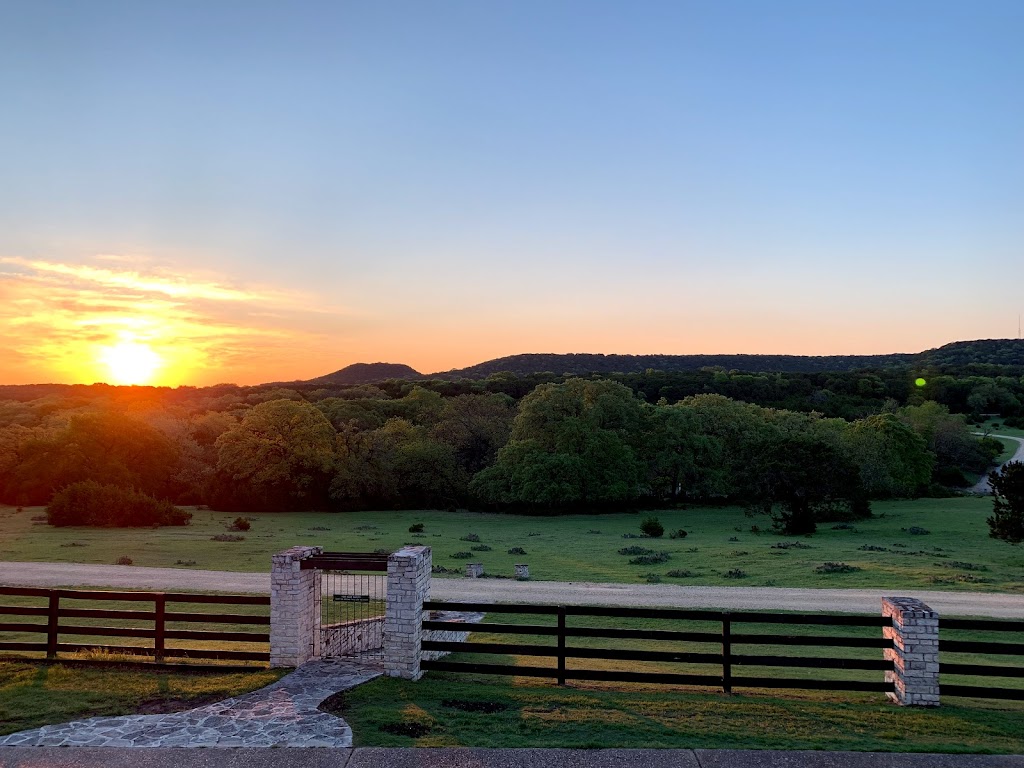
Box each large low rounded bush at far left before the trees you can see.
[46,480,191,528]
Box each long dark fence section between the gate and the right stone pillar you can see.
[422,601,894,692]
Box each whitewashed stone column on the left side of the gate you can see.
[270,547,324,667]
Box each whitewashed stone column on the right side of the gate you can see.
[384,547,431,680]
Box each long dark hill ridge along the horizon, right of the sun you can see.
[299,339,1024,384]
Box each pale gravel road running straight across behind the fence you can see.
[0,562,1024,618]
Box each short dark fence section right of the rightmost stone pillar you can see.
[939,618,1024,701]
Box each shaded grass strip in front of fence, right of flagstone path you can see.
[336,673,1024,753]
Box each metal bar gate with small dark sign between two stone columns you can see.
[301,552,387,658]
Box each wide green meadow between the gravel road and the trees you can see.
[0,498,1024,592]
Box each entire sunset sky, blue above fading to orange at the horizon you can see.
[0,0,1024,386]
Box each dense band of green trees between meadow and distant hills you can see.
[0,369,1024,530]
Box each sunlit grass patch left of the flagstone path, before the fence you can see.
[0,660,287,735]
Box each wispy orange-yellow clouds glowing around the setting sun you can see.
[0,256,344,384]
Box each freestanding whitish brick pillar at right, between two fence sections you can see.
[882,597,939,707]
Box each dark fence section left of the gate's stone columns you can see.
[0,587,270,664]
